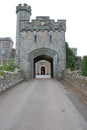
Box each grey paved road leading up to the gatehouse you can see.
[0,79,87,130]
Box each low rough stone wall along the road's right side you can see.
[63,69,87,95]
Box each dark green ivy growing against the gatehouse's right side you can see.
[66,42,76,70]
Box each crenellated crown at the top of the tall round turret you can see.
[16,4,31,14]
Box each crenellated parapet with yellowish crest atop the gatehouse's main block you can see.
[20,16,66,32]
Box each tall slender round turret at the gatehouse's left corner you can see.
[16,4,31,64]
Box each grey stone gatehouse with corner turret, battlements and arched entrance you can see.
[16,4,66,79]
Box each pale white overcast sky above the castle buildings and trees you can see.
[0,0,87,57]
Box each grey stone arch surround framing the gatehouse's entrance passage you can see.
[28,48,60,78]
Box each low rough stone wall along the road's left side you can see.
[0,72,23,92]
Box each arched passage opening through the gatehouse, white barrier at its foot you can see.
[34,55,53,78]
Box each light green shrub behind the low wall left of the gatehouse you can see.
[0,60,18,75]
